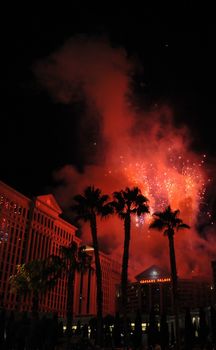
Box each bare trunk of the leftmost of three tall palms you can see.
[90,214,103,345]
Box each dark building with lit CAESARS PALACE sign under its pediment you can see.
[121,265,212,317]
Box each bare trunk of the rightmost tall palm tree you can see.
[168,233,180,350]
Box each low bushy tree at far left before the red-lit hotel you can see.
[9,255,62,316]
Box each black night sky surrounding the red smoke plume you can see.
[0,3,213,196]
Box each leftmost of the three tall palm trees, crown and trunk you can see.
[72,186,113,344]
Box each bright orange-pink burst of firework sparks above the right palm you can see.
[106,149,206,223]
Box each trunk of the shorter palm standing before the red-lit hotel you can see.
[67,266,75,337]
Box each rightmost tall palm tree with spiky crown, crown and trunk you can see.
[149,206,190,349]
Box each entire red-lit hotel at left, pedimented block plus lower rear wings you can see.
[0,181,120,318]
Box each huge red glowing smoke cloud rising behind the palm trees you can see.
[35,38,214,278]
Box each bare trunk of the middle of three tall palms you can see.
[121,214,131,346]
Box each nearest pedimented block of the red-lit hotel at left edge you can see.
[0,182,80,317]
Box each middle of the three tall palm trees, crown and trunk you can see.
[112,187,149,344]
